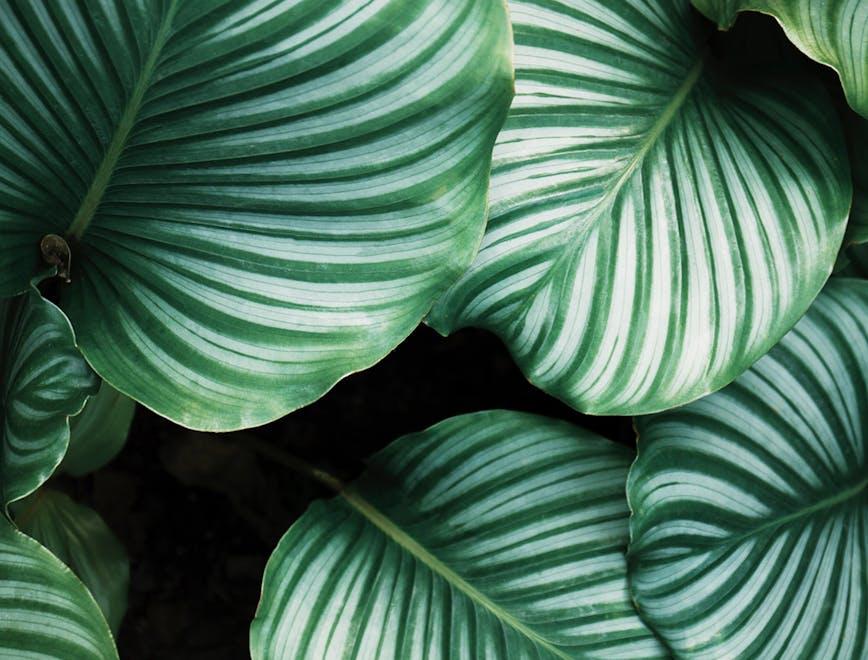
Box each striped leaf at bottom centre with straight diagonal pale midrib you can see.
[251,411,662,658]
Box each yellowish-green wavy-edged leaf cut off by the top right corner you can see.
[693,0,868,118]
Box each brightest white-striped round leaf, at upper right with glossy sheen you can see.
[429,0,851,414]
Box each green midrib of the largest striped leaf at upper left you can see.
[66,0,177,239]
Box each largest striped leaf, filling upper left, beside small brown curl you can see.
[0,0,512,431]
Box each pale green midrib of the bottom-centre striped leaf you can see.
[339,488,570,660]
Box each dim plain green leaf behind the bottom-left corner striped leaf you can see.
[15,488,130,634]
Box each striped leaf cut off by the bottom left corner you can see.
[0,516,118,660]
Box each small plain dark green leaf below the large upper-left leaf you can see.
[61,381,136,477]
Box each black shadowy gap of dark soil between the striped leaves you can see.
[64,326,633,660]
